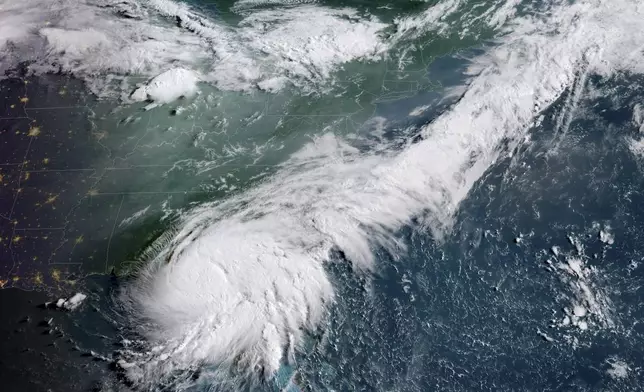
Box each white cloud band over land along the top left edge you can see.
[0,0,386,95]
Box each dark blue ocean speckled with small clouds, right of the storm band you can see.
[302,78,644,391]
